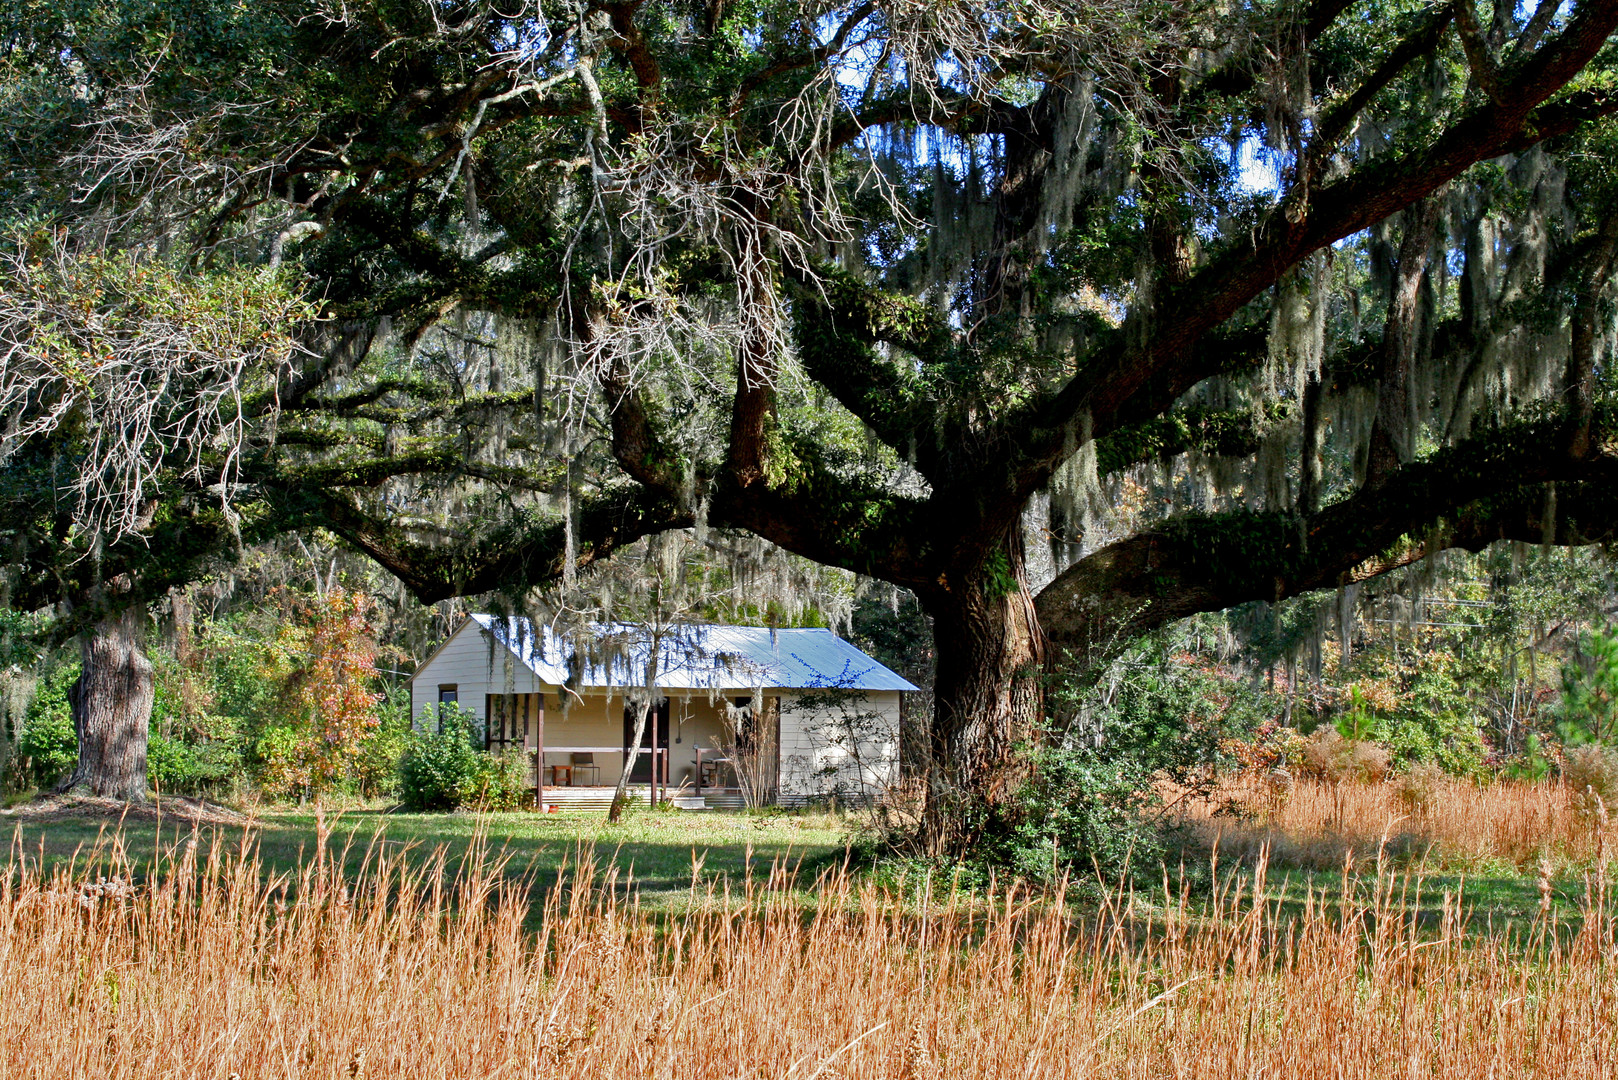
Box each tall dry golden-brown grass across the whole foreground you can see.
[0,822,1618,1080]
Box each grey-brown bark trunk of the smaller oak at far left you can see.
[61,606,154,803]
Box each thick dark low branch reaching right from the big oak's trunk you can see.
[1036,409,1618,664]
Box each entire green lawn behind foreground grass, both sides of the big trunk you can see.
[0,799,1584,933]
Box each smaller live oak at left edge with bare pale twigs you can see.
[0,236,618,801]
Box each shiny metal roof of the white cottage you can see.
[471,615,919,690]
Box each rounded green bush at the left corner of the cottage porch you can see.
[398,703,527,811]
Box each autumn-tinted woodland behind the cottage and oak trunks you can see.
[0,524,1618,878]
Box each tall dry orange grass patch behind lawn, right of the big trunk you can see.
[1184,771,1618,874]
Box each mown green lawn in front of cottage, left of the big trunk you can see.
[0,810,849,907]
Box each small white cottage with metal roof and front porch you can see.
[411,615,916,808]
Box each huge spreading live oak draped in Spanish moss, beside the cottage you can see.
[9,0,1618,848]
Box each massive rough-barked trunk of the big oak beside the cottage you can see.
[922,538,1044,855]
